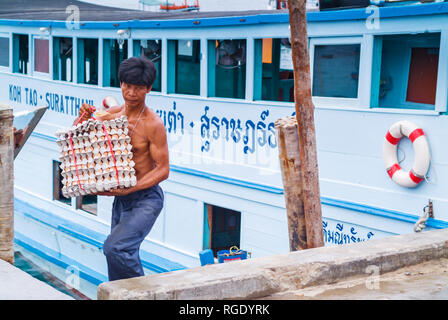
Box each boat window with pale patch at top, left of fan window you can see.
[168,39,201,95]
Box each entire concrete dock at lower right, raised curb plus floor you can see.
[98,229,448,300]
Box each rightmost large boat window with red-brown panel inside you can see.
[372,33,440,110]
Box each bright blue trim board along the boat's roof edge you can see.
[0,3,448,29]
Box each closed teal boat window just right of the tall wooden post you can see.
[312,44,361,98]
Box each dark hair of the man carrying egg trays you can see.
[118,57,157,88]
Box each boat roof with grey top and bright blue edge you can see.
[0,0,448,29]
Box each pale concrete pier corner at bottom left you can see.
[0,260,74,300]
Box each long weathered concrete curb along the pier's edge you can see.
[98,229,448,300]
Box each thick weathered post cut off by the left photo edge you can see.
[0,105,14,264]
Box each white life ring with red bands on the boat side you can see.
[383,120,431,188]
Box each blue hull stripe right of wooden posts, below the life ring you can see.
[321,197,448,229]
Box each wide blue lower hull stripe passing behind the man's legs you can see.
[14,198,186,273]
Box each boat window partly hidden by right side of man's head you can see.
[134,39,162,92]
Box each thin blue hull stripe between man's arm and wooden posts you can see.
[170,165,283,194]
